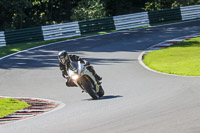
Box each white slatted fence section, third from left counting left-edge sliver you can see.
[113,12,149,30]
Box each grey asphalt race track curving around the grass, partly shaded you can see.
[0,20,200,133]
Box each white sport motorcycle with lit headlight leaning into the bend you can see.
[67,61,104,99]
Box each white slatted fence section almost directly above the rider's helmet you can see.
[42,22,81,41]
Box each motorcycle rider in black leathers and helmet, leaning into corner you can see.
[58,50,102,87]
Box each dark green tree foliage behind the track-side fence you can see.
[0,0,200,31]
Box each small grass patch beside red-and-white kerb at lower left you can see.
[0,98,30,118]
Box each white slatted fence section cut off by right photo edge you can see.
[181,5,200,20]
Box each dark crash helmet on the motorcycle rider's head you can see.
[58,50,71,65]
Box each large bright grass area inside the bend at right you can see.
[143,37,200,76]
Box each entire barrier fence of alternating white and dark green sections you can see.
[0,5,200,46]
